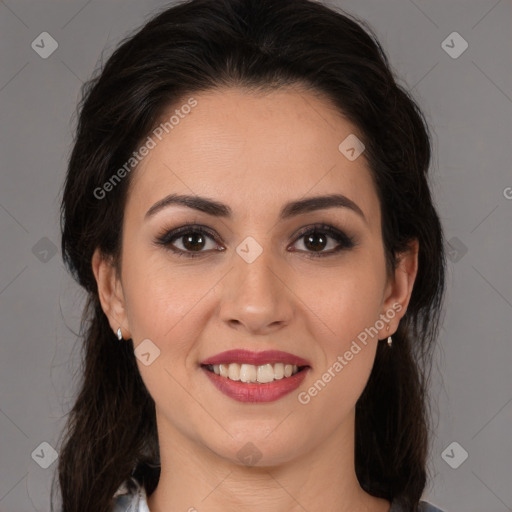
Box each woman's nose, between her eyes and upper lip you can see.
[219,244,295,335]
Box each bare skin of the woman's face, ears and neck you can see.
[92,87,418,512]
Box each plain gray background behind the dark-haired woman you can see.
[0,0,512,512]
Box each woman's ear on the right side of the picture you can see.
[379,239,419,339]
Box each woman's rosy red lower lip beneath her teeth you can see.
[202,367,309,402]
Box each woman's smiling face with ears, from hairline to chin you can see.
[93,88,412,465]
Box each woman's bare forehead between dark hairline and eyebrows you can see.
[126,88,378,225]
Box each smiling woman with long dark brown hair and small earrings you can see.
[58,0,445,512]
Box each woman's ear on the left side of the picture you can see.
[92,248,131,339]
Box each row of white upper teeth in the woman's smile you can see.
[209,363,299,384]
